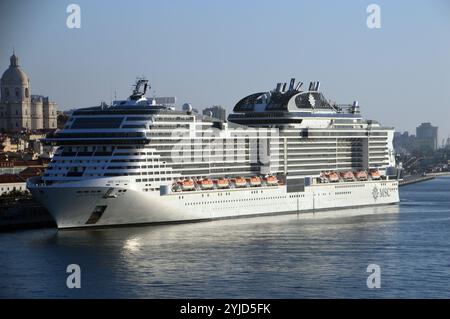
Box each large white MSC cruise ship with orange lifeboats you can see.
[27,78,399,228]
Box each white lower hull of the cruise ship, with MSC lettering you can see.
[27,178,399,228]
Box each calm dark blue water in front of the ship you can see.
[0,177,450,298]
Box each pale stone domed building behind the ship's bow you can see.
[0,53,57,132]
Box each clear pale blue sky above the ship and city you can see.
[0,0,450,140]
